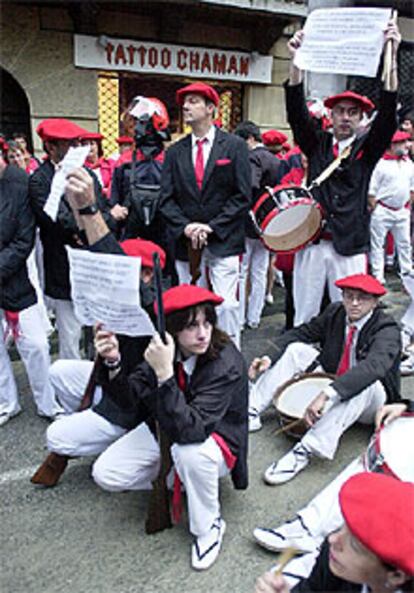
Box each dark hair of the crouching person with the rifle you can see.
[165,303,230,360]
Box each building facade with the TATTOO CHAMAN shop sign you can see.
[0,0,307,152]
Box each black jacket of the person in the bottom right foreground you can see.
[291,540,362,593]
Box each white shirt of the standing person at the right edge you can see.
[368,159,414,209]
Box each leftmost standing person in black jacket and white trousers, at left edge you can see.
[0,156,59,425]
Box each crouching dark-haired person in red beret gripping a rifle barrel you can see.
[86,285,248,570]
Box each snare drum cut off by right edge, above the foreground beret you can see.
[364,413,414,482]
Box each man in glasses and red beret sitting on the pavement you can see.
[249,274,401,485]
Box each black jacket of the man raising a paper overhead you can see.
[285,84,397,255]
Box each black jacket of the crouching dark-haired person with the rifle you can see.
[99,342,248,488]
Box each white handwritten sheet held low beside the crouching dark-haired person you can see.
[66,247,154,336]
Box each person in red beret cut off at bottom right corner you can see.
[255,472,414,593]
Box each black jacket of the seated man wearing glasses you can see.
[277,303,401,403]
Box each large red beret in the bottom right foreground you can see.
[339,472,414,576]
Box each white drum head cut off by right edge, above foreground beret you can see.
[379,414,414,482]
